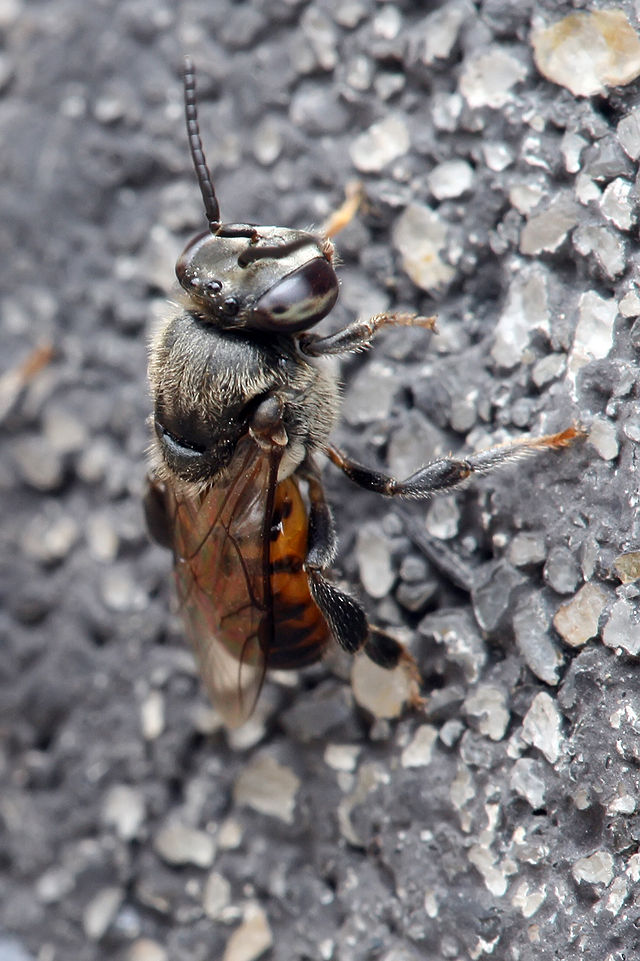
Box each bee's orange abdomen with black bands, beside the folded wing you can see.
[267,478,331,669]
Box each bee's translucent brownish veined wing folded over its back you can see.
[166,437,279,727]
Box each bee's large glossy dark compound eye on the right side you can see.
[251,257,338,332]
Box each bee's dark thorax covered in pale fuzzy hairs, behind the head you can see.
[149,310,339,486]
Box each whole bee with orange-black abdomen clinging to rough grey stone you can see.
[145,58,578,727]
